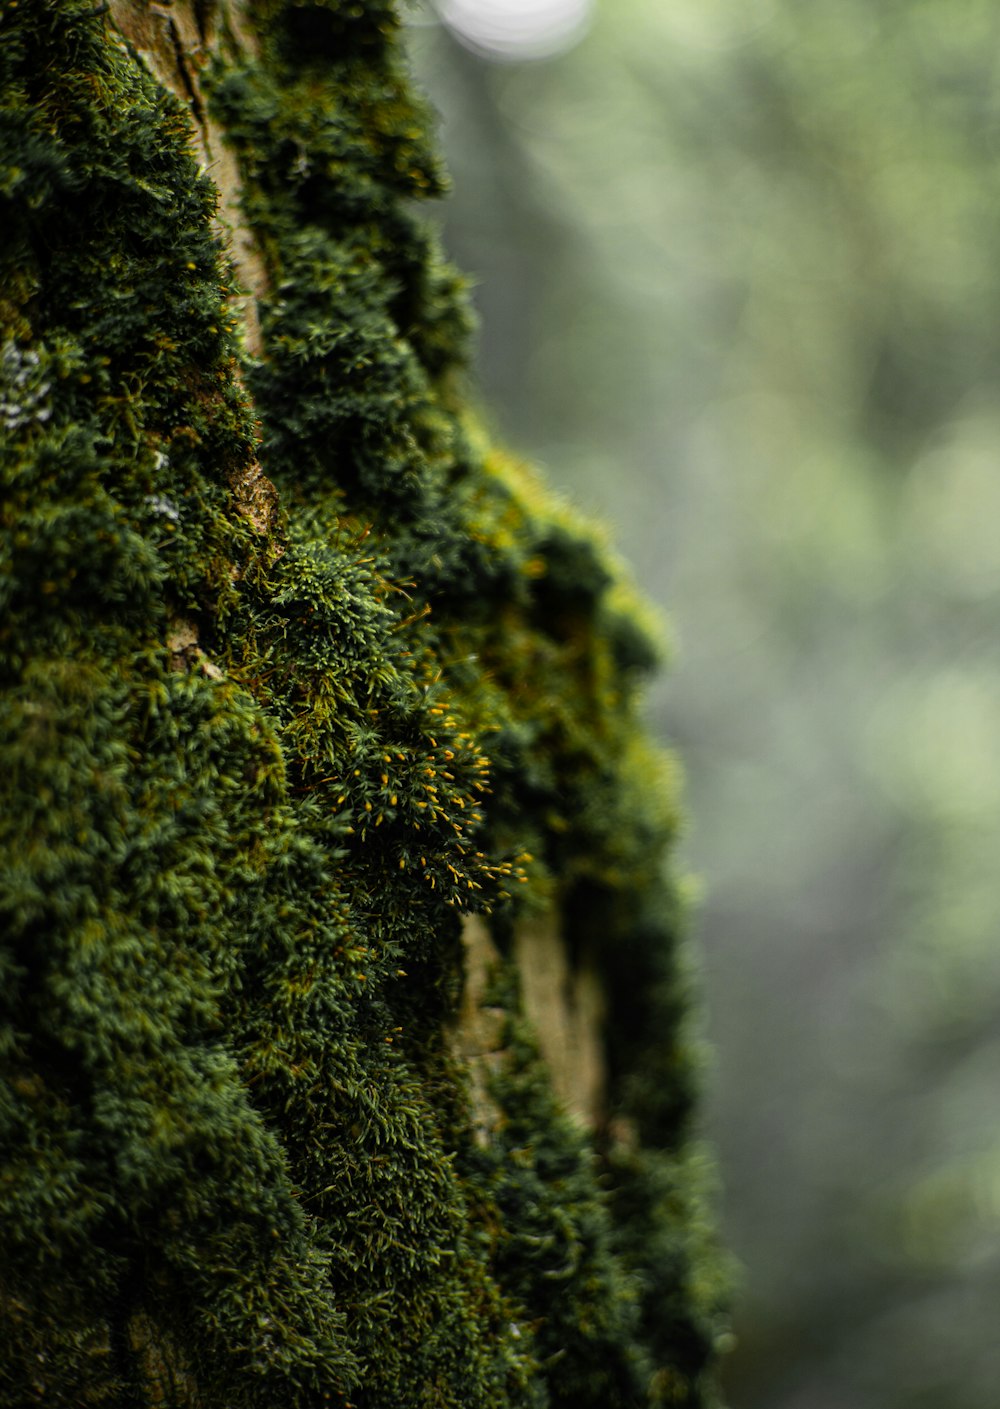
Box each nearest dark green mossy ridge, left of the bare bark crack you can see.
[0,0,356,1406]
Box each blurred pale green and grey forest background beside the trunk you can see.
[410,0,1000,1409]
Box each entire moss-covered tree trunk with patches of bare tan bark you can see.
[0,0,720,1409]
